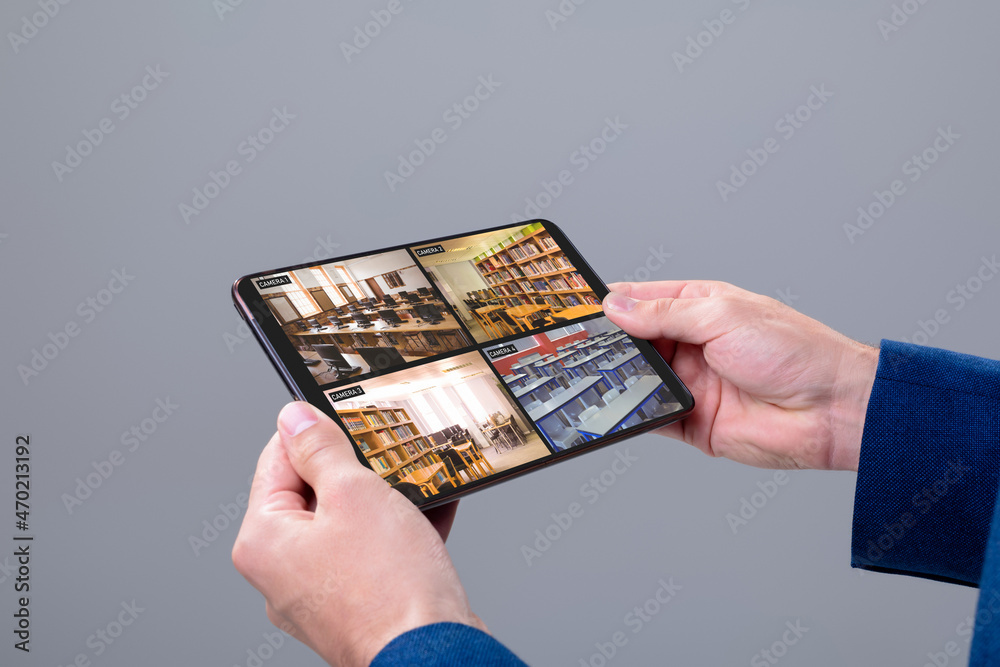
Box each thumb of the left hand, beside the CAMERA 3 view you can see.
[278,401,361,494]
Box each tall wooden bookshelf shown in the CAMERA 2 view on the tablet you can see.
[473,223,601,309]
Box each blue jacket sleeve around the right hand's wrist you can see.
[851,341,1000,585]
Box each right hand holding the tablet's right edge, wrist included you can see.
[604,281,878,471]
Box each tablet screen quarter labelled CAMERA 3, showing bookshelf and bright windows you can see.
[326,351,552,504]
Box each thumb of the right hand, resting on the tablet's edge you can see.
[604,292,732,345]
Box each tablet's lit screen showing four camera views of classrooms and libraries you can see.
[254,223,680,503]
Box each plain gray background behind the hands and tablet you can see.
[0,0,1000,667]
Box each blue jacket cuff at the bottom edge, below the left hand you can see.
[371,623,527,667]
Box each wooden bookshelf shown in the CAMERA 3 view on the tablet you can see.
[337,408,441,484]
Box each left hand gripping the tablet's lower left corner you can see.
[233,402,486,666]
